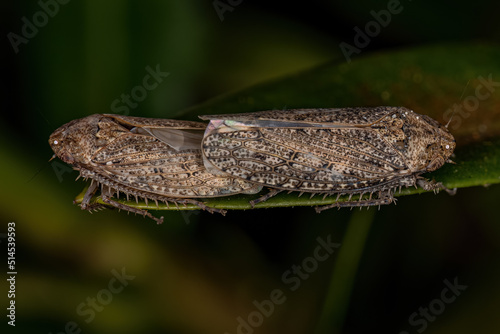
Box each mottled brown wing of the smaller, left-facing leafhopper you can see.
[91,115,258,198]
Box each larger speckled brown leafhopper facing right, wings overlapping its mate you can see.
[200,107,455,212]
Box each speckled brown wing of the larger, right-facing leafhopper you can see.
[203,108,416,193]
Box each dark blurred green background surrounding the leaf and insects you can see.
[0,0,500,333]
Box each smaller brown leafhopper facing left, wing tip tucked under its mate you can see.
[49,114,261,223]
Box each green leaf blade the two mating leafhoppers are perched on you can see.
[76,44,500,210]
